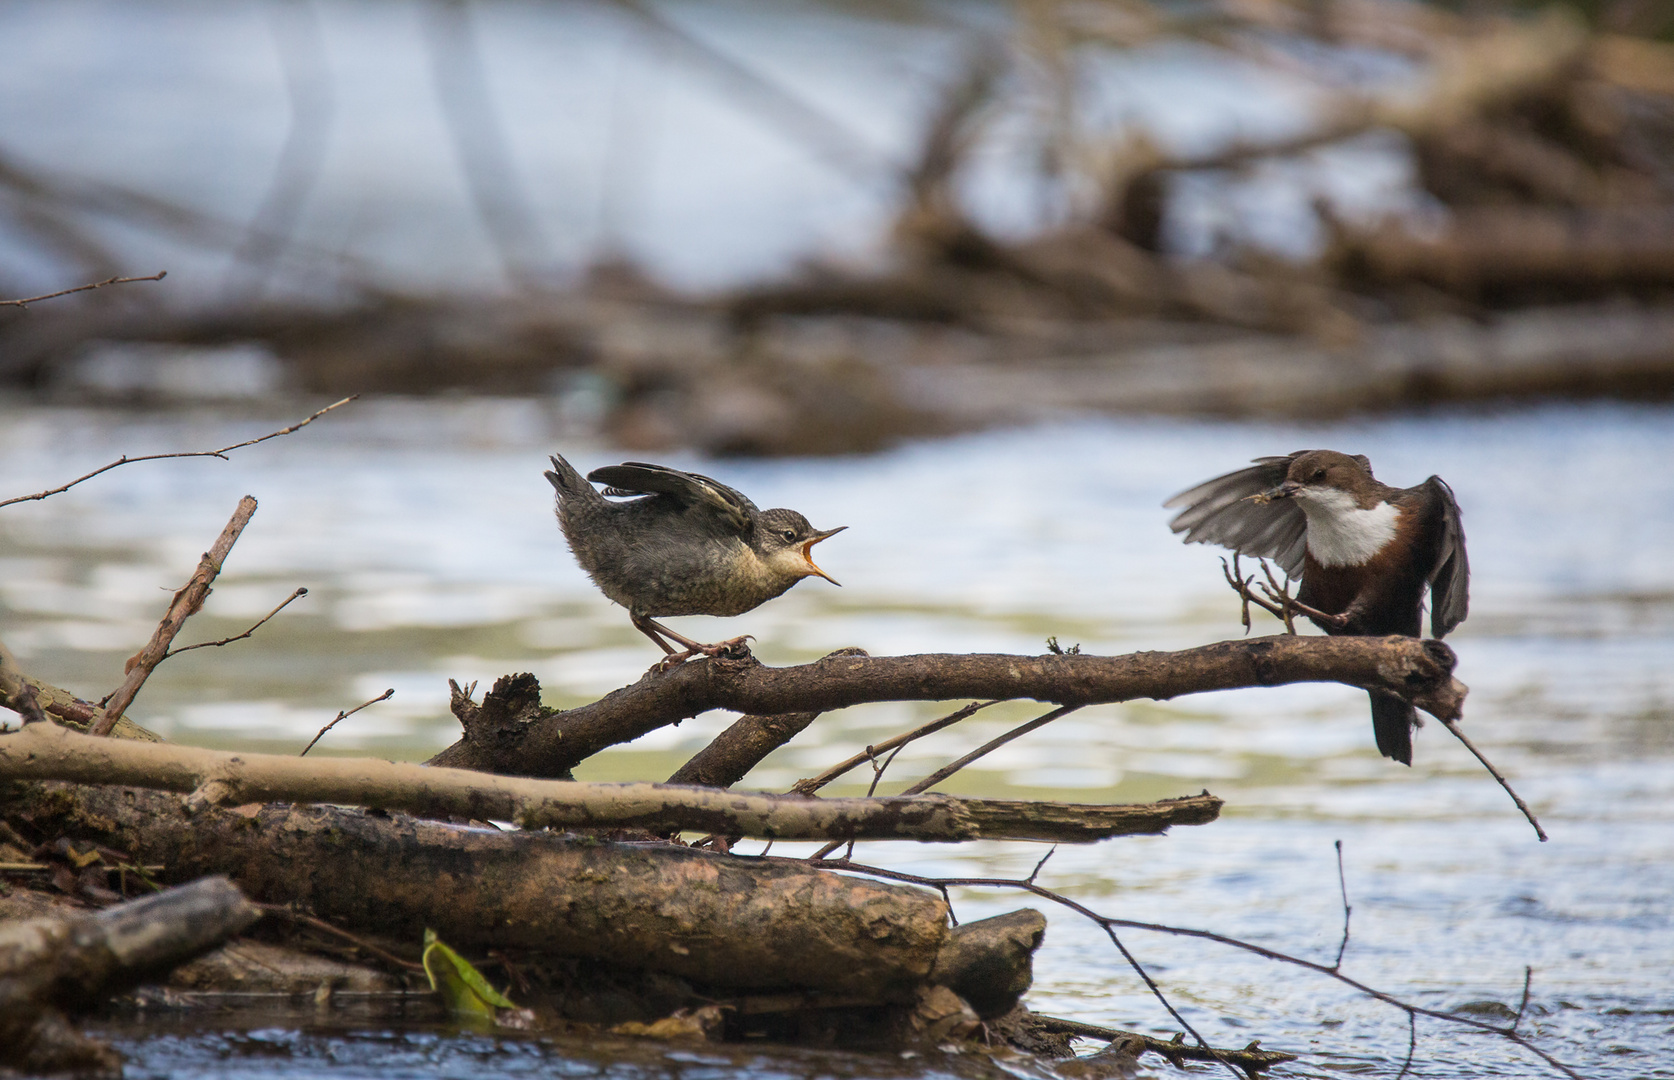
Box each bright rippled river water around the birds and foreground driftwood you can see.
[0,400,1674,1077]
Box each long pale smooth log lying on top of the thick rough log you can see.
[0,723,1220,842]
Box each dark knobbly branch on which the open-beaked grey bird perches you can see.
[430,635,1466,777]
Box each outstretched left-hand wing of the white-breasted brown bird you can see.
[1163,450,1307,578]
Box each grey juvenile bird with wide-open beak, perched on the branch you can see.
[546,455,849,663]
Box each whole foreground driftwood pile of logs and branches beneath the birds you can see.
[0,468,1466,1072]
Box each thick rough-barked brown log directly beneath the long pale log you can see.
[0,773,947,1001]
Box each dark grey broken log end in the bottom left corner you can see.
[0,877,261,1072]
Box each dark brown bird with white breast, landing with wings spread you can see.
[1163,450,1470,765]
